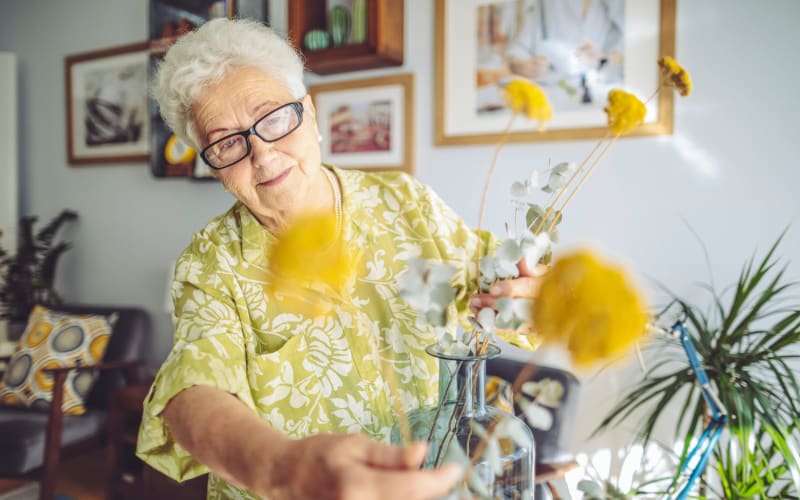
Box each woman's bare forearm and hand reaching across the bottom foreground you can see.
[164,385,461,500]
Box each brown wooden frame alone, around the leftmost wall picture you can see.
[64,42,150,165]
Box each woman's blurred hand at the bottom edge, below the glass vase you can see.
[262,434,462,500]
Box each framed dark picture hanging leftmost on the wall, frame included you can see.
[64,42,150,165]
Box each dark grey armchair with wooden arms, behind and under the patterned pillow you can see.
[0,305,151,500]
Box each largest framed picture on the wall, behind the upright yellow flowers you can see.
[435,0,675,145]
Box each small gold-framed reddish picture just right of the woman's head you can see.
[309,74,414,173]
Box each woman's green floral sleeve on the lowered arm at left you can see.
[136,241,255,481]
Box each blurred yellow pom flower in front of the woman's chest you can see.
[267,214,354,312]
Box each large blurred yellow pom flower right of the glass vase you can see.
[533,250,648,366]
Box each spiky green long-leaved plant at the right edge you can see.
[595,232,800,498]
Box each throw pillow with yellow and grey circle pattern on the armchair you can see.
[0,306,116,415]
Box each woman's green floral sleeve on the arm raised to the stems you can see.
[414,181,498,321]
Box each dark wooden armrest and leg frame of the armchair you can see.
[0,356,140,500]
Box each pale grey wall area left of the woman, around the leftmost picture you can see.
[0,0,231,365]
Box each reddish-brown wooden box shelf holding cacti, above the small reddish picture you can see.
[289,0,405,75]
